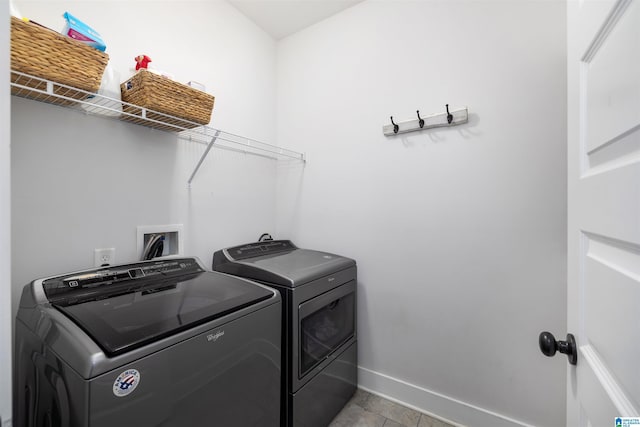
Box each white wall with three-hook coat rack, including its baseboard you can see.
[276,0,566,427]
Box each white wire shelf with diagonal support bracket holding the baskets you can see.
[11,70,306,184]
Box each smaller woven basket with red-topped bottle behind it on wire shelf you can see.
[120,70,215,131]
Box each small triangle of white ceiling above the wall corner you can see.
[229,0,363,40]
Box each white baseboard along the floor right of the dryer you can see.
[358,366,533,427]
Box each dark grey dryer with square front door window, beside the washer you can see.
[213,240,357,427]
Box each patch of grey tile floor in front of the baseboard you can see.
[329,389,452,427]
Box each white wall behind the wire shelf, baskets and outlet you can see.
[10,1,276,354]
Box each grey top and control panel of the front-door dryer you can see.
[213,240,356,287]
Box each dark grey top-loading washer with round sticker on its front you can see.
[13,258,282,427]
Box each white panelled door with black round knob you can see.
[568,0,640,427]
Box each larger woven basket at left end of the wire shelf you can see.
[11,16,109,105]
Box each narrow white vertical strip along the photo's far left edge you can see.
[0,0,11,426]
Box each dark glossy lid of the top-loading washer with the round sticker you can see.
[52,260,274,356]
